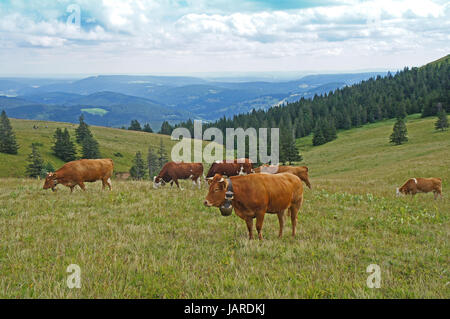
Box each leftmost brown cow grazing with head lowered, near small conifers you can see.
[44,158,114,192]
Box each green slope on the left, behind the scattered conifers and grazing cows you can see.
[0,119,179,177]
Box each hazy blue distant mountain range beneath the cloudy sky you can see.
[0,72,386,129]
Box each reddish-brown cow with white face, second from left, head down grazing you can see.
[153,162,203,189]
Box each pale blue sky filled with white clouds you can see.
[0,0,450,76]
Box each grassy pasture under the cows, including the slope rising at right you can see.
[0,116,450,298]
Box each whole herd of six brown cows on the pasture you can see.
[44,159,442,239]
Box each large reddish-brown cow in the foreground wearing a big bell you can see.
[203,173,303,239]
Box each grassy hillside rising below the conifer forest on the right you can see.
[297,114,450,195]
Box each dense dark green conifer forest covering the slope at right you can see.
[175,55,450,150]
